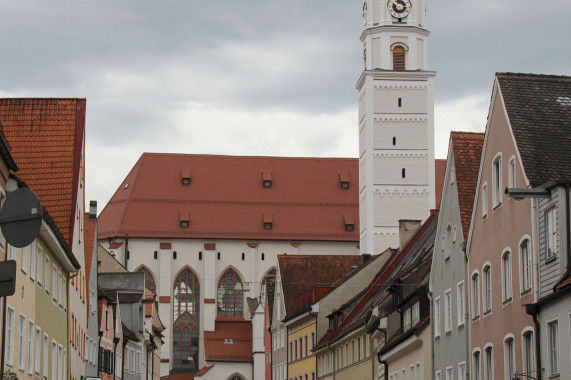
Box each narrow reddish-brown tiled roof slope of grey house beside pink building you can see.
[450,132,485,241]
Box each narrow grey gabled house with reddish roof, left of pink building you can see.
[429,132,484,380]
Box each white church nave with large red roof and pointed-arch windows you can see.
[98,154,359,380]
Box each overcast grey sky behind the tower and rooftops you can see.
[0,0,571,211]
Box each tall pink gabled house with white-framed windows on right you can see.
[466,74,536,380]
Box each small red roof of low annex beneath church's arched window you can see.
[204,320,253,362]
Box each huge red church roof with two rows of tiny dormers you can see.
[98,153,359,242]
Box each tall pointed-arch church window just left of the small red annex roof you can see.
[172,268,200,372]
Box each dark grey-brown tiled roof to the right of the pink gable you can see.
[496,73,571,187]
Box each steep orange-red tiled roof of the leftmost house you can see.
[0,99,85,247]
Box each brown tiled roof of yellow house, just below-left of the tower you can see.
[278,255,361,319]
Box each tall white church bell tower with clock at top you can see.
[356,0,436,254]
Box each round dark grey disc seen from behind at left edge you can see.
[0,188,43,248]
